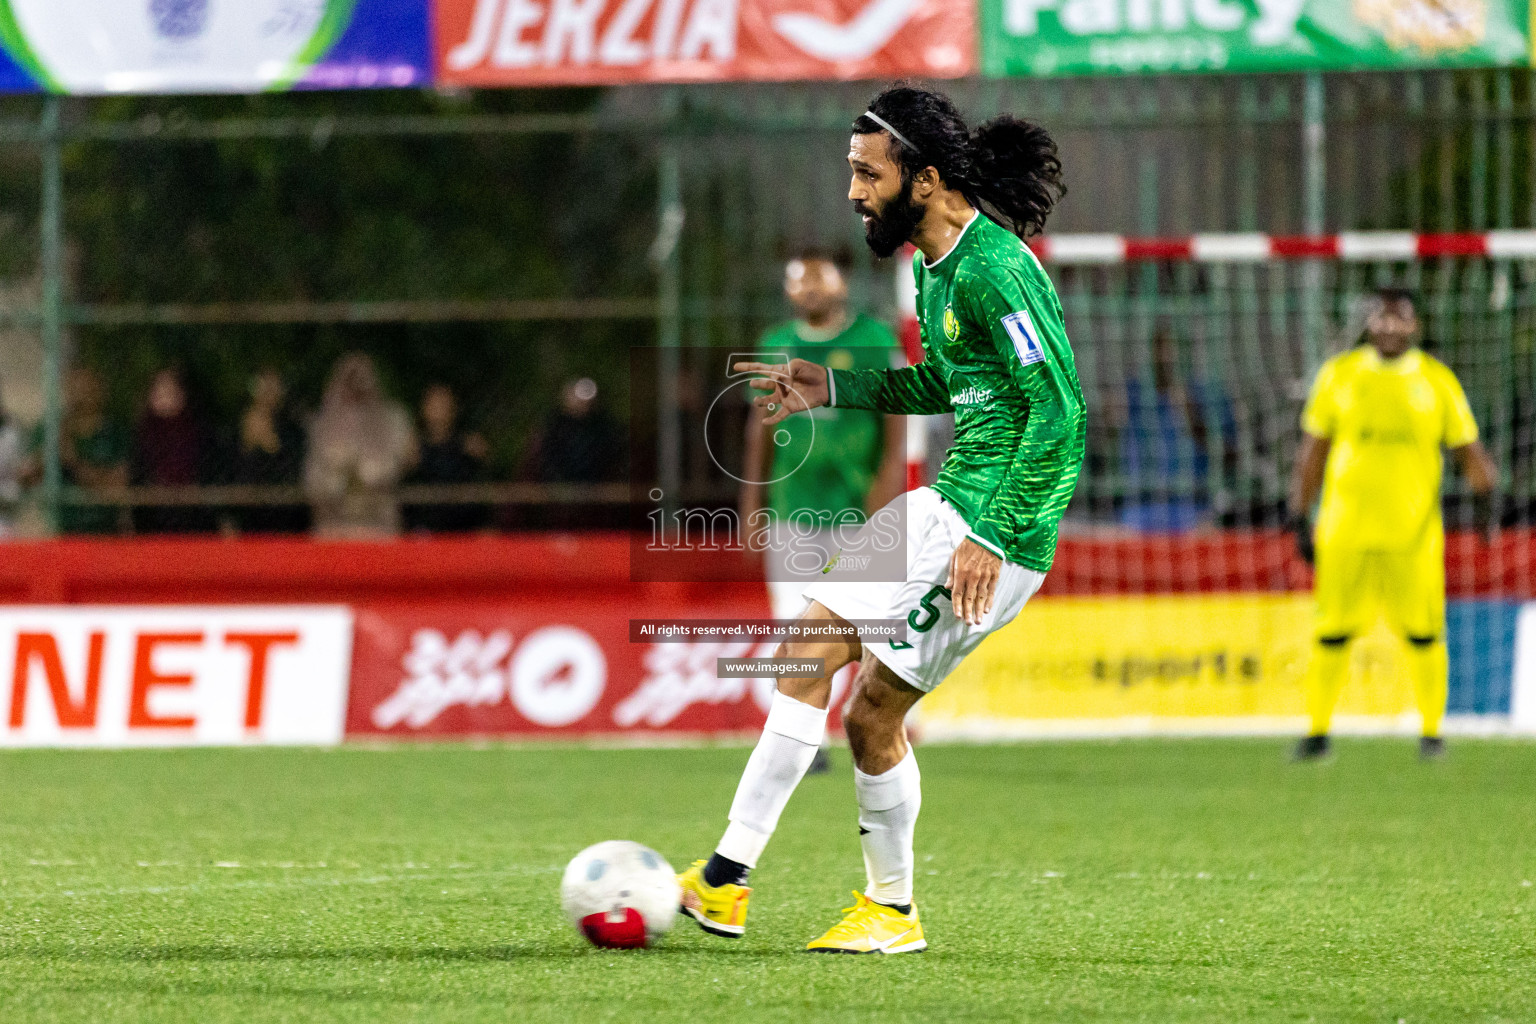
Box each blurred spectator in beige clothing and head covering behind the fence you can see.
[304,352,416,537]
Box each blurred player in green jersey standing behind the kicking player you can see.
[740,246,906,775]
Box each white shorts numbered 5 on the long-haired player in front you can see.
[805,487,1046,694]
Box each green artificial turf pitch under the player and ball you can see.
[0,740,1536,1024]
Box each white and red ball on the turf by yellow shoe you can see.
[561,840,682,949]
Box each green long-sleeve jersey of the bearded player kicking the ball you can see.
[828,213,1087,573]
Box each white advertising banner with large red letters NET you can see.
[0,605,352,746]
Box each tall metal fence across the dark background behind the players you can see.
[0,71,1536,530]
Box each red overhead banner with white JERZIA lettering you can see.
[433,0,975,86]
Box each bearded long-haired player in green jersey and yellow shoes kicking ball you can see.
[679,86,1086,953]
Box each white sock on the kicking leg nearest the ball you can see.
[714,691,826,867]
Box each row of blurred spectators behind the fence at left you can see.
[0,352,624,537]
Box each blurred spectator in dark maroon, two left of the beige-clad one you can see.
[129,365,215,533]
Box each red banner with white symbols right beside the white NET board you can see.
[347,599,851,737]
